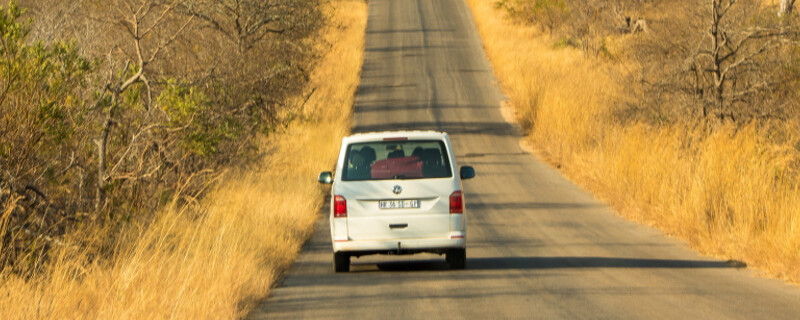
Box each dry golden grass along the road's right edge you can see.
[467,0,800,282]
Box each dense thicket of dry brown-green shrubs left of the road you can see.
[0,0,327,274]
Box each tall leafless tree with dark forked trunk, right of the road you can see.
[689,0,797,121]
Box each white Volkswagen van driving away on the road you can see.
[319,131,475,272]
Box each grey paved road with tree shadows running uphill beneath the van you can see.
[245,0,800,319]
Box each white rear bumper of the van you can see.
[333,237,467,255]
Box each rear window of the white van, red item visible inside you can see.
[342,140,453,181]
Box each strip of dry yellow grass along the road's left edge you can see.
[0,0,366,319]
